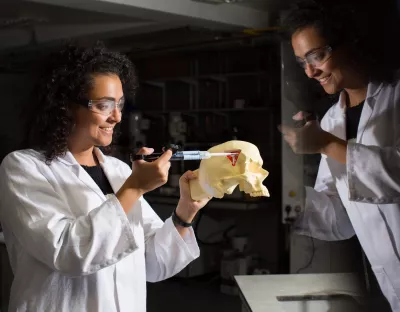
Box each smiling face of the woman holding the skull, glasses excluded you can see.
[70,74,124,149]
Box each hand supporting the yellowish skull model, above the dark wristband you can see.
[176,170,211,223]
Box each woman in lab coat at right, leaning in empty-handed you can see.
[281,1,400,312]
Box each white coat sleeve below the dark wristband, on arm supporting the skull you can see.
[142,199,200,282]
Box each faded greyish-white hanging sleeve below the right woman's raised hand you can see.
[293,156,355,241]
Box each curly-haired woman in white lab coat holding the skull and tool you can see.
[0,46,211,312]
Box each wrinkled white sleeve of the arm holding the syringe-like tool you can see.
[0,153,137,276]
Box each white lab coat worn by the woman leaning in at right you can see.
[295,82,400,312]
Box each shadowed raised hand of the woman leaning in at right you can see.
[279,112,330,154]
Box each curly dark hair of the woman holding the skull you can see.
[28,42,138,164]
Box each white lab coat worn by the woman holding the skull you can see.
[0,149,199,312]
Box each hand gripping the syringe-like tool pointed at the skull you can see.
[128,147,172,194]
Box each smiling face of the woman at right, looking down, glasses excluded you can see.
[292,27,357,94]
